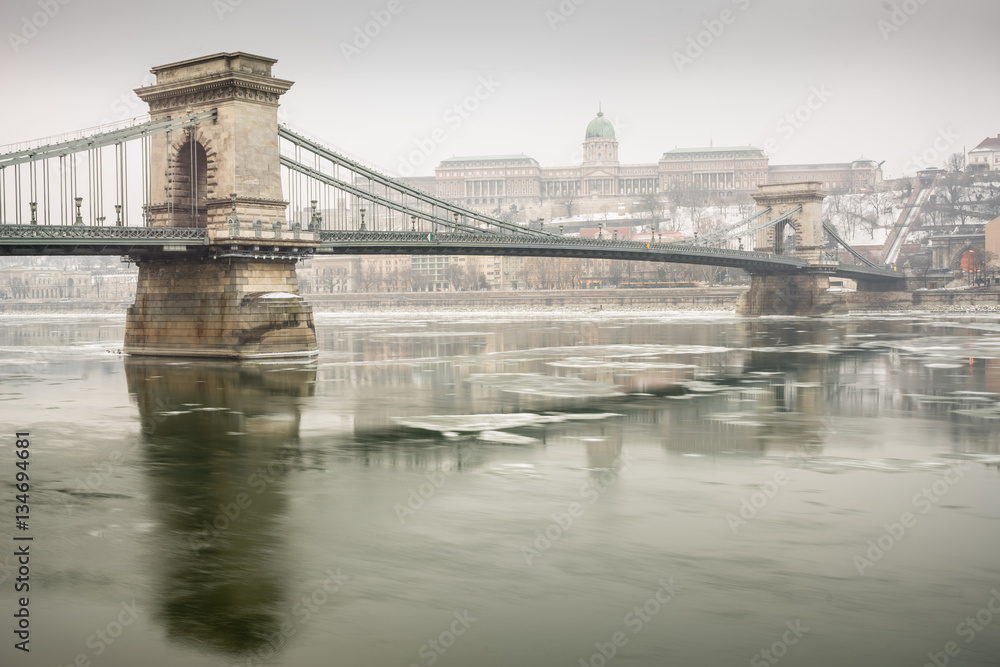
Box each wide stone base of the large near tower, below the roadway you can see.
[125,258,317,359]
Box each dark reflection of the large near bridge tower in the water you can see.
[125,358,315,658]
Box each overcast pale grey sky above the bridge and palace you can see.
[0,0,1000,176]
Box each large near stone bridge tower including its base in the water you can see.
[125,53,316,358]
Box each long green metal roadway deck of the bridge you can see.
[0,225,903,280]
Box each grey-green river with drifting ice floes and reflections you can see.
[0,312,1000,667]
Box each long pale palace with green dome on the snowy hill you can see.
[403,111,882,222]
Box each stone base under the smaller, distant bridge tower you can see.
[736,274,846,317]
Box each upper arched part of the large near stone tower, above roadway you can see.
[135,53,292,229]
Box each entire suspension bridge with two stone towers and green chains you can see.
[0,52,902,358]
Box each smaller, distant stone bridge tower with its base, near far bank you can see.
[737,182,839,317]
